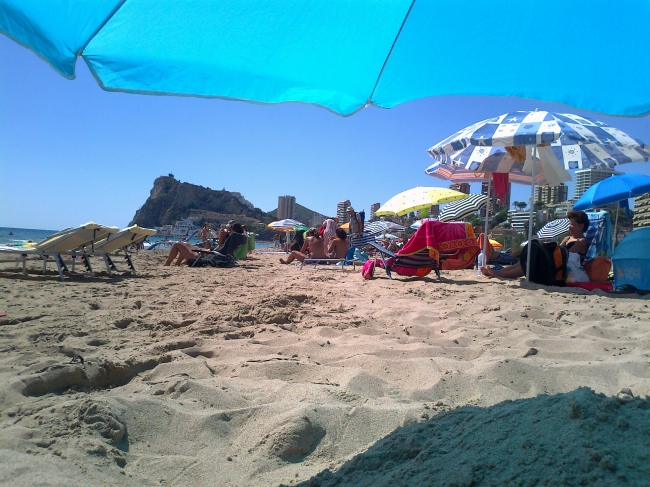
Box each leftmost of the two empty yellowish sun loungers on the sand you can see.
[0,222,119,280]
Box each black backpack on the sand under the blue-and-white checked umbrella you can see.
[519,240,569,286]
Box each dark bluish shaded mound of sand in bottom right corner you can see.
[294,387,650,487]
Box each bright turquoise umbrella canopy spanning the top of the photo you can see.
[0,0,650,115]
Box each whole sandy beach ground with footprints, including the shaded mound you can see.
[0,251,650,486]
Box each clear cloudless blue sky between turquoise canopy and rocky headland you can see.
[0,35,650,230]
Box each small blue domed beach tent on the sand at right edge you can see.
[612,228,650,291]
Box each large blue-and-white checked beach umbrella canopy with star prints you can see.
[425,111,650,185]
